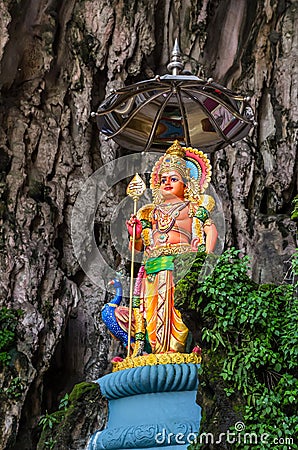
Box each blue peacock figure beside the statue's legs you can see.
[101,279,135,347]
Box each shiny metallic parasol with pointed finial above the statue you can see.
[93,40,254,153]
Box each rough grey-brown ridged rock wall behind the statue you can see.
[0,0,298,450]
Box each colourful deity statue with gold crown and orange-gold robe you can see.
[126,141,217,357]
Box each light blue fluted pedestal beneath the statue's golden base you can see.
[87,363,201,450]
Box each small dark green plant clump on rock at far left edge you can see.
[0,307,23,367]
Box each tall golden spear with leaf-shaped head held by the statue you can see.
[126,173,146,356]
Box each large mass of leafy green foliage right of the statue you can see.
[177,249,298,450]
